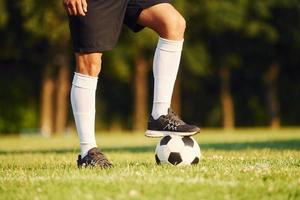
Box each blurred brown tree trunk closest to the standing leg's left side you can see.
[54,64,70,134]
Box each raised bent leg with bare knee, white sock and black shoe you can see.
[137,3,199,137]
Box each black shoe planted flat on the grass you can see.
[77,147,113,169]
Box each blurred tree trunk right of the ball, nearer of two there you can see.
[220,67,234,129]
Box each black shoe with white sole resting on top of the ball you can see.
[145,108,200,137]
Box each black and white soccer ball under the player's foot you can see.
[155,135,201,165]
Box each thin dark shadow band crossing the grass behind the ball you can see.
[0,139,300,155]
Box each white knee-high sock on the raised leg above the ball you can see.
[152,37,183,119]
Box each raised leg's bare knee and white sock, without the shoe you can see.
[138,3,185,119]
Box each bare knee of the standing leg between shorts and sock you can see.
[76,53,102,77]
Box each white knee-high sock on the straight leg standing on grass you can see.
[71,73,98,157]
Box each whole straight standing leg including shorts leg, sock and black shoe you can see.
[69,0,127,168]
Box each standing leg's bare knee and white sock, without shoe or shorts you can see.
[71,53,101,157]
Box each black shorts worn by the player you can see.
[69,0,171,53]
